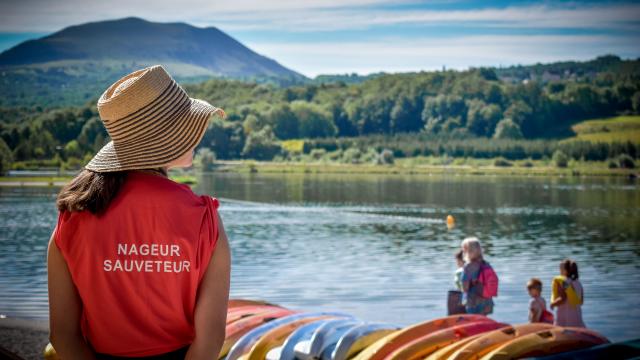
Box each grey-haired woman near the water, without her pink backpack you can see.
[461,237,493,315]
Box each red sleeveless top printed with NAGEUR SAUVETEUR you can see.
[54,171,219,356]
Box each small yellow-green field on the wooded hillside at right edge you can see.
[568,116,640,143]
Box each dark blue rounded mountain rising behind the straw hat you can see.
[0,17,306,105]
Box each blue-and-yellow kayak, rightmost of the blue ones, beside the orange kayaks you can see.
[331,323,399,360]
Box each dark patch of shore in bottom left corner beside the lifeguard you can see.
[0,318,49,360]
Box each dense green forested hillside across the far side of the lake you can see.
[0,57,640,173]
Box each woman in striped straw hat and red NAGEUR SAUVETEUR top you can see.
[47,66,230,359]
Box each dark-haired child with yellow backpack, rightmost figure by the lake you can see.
[551,259,586,327]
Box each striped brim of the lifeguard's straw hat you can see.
[85,98,221,172]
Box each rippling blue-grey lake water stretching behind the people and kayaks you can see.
[0,174,640,340]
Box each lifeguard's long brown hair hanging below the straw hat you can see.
[56,168,167,216]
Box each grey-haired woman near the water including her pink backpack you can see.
[461,237,498,315]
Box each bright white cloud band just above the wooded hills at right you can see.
[249,35,640,76]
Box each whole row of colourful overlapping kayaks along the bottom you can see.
[225,300,640,360]
